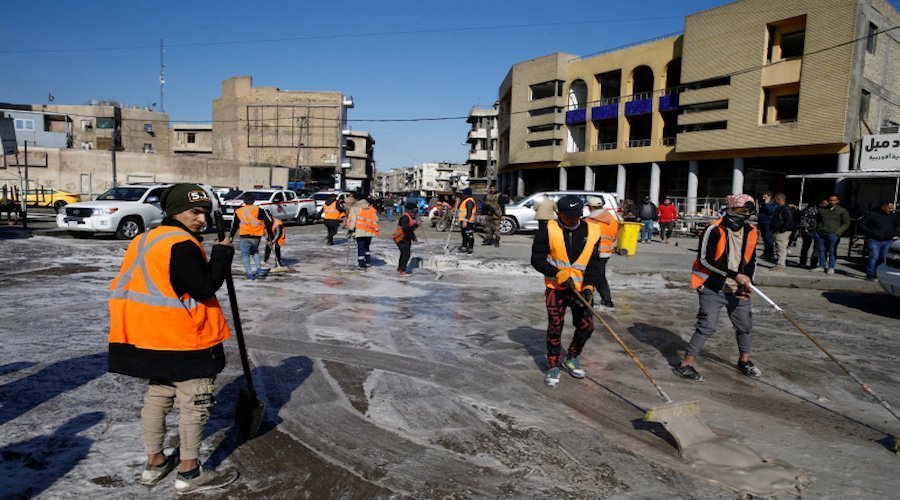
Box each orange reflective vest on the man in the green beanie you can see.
[109,226,231,351]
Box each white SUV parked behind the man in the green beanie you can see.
[56,184,219,240]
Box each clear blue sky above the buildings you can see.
[0,0,896,171]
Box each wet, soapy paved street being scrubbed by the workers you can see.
[0,223,900,498]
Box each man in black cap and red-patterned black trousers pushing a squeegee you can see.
[531,195,600,387]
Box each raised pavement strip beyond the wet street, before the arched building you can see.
[404,228,882,293]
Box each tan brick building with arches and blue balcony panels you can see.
[499,0,900,213]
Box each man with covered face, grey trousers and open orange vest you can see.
[673,194,761,382]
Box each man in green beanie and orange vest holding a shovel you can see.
[109,184,235,493]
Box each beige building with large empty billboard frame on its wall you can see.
[212,76,353,187]
